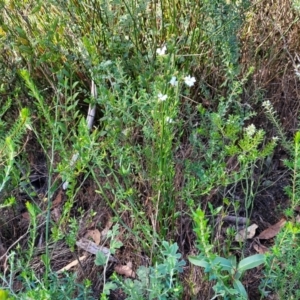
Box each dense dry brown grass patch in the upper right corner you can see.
[241,0,300,137]
